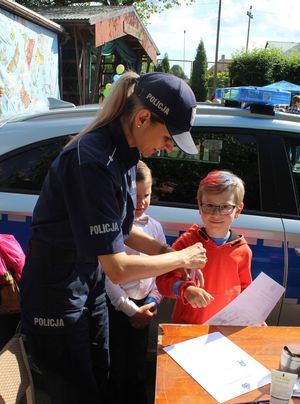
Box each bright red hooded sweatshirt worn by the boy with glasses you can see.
[156,224,252,324]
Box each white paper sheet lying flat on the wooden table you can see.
[164,332,271,403]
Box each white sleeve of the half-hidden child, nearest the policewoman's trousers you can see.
[105,276,139,317]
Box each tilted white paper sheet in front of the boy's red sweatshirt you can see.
[205,272,285,326]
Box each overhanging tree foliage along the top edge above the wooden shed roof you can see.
[17,0,195,23]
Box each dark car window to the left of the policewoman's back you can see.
[0,136,69,194]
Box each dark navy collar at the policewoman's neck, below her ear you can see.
[108,119,141,170]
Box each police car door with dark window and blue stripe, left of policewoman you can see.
[0,136,67,250]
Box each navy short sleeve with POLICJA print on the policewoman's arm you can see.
[63,153,126,255]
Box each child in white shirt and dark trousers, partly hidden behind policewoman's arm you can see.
[106,161,166,404]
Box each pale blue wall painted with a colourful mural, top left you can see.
[0,8,59,115]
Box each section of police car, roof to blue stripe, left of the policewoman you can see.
[0,113,96,250]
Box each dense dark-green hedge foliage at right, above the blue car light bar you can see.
[229,48,300,86]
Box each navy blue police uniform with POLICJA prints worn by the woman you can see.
[20,121,140,404]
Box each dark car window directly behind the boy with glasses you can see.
[145,128,260,210]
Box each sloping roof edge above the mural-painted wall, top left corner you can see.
[0,0,64,32]
